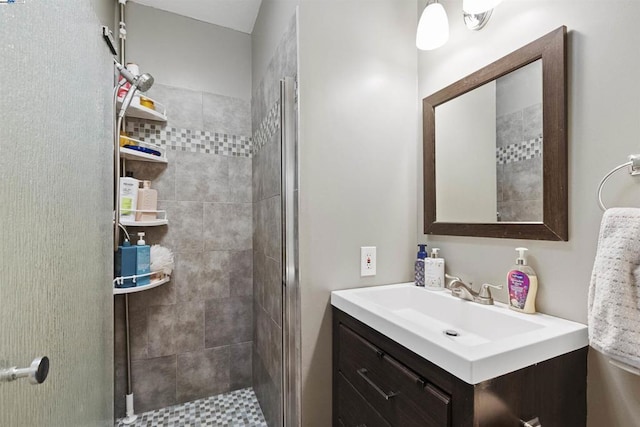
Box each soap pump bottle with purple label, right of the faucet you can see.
[507,248,538,313]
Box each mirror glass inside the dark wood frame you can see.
[435,59,543,223]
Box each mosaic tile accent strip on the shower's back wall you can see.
[125,119,252,157]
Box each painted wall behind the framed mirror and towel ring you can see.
[418,0,640,427]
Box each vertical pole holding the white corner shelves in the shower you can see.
[114,0,138,424]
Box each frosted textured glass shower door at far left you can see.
[0,0,113,427]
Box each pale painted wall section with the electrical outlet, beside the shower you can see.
[299,0,419,427]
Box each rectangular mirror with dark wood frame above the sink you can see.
[423,26,569,241]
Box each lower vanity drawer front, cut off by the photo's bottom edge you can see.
[337,374,391,427]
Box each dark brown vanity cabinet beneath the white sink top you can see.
[333,308,587,427]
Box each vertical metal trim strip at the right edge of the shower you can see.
[280,77,301,427]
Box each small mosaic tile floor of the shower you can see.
[115,388,267,427]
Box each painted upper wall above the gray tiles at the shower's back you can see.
[126,2,251,101]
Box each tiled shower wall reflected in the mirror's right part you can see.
[496,104,542,222]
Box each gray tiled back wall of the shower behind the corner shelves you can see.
[115,84,254,417]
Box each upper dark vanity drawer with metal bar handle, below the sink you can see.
[338,324,451,427]
